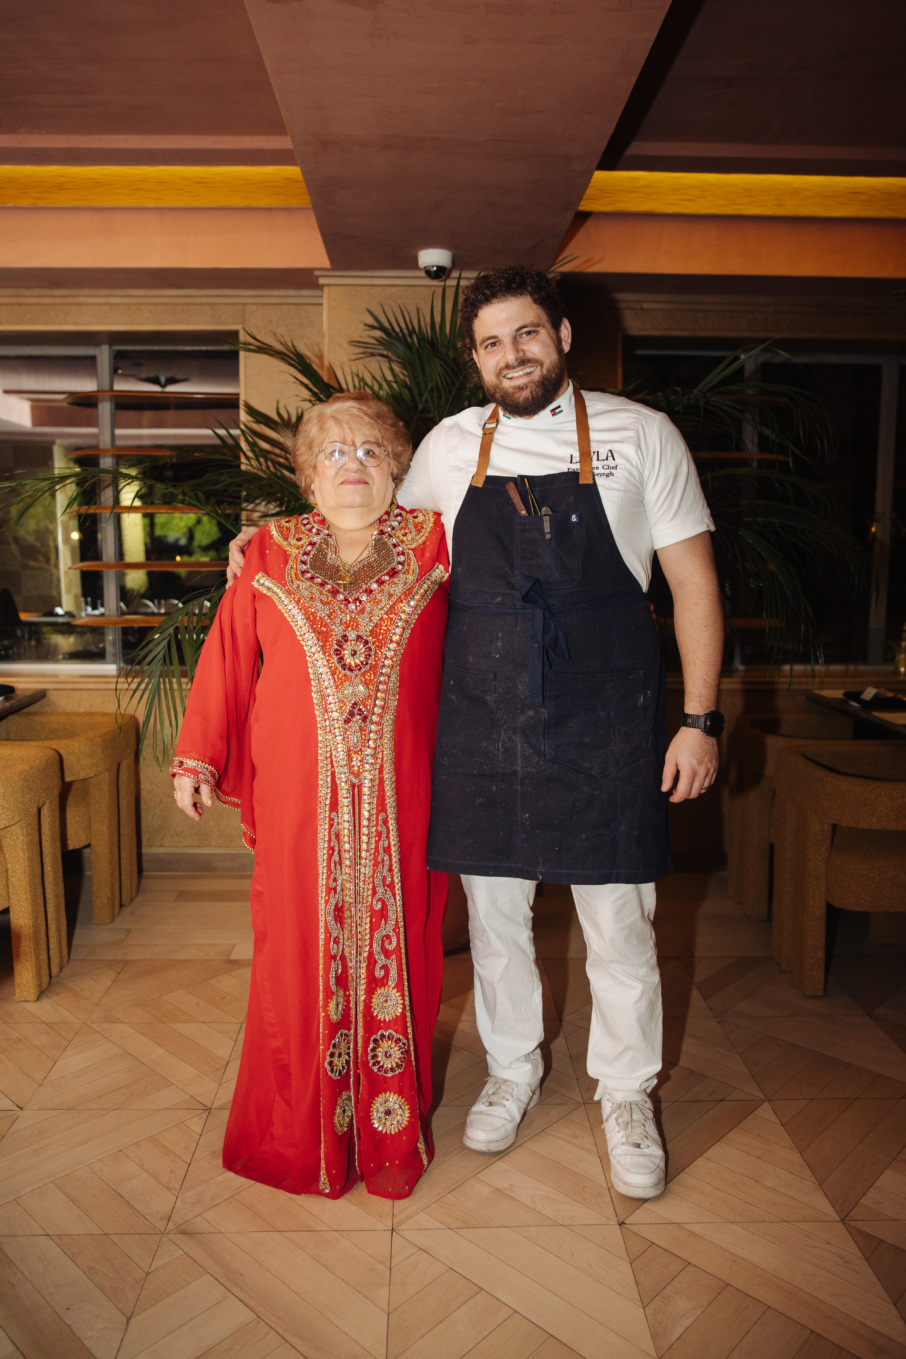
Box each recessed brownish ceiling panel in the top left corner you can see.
[0,0,292,164]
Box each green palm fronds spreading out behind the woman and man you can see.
[0,283,868,764]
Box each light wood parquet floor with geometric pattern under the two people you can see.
[0,875,906,1359]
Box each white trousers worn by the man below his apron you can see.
[462,875,663,1099]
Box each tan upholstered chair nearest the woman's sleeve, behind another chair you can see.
[0,712,139,924]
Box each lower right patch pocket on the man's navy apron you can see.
[545,667,652,779]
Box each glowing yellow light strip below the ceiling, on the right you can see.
[579,170,906,217]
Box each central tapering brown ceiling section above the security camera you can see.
[246,0,668,269]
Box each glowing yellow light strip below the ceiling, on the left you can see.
[0,166,311,208]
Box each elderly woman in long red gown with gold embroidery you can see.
[171,391,448,1199]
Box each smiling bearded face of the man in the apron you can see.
[471,295,572,416]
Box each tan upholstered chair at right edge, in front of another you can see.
[773,741,906,996]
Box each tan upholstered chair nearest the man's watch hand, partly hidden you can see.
[727,712,853,920]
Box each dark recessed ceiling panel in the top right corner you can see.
[600,0,906,175]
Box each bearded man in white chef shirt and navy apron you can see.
[231,265,724,1199]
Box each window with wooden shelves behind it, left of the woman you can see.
[0,337,239,666]
